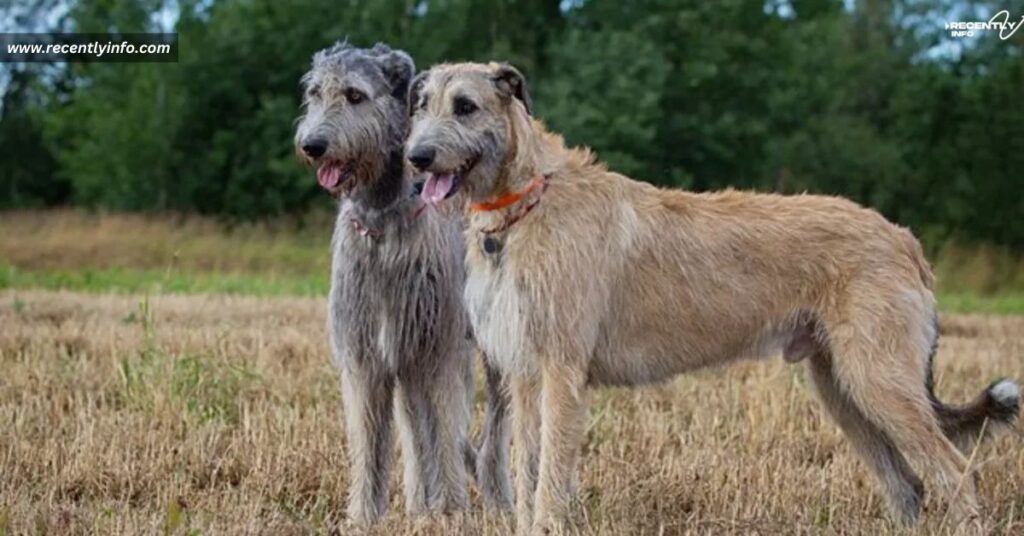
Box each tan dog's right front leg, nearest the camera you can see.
[532,362,588,534]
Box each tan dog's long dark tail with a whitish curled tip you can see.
[925,321,1021,451]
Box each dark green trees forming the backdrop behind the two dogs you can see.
[0,0,1024,249]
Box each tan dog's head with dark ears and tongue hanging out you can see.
[406,64,530,203]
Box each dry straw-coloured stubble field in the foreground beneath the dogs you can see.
[0,289,1024,535]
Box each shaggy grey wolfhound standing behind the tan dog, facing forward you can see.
[295,43,511,525]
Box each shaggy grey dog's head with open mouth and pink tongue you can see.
[295,42,415,195]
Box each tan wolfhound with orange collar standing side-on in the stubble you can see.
[407,64,1019,532]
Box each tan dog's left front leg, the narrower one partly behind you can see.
[510,375,541,535]
